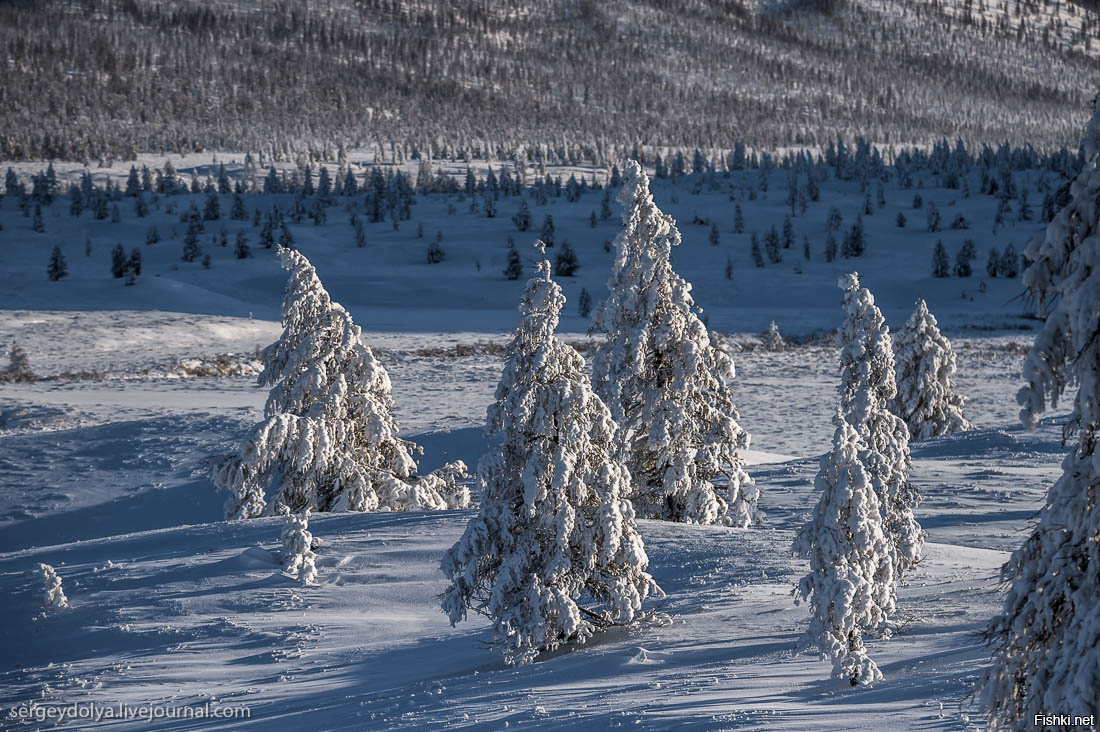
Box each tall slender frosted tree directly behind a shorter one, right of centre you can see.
[837,273,924,583]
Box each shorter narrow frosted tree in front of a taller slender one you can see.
[793,414,895,686]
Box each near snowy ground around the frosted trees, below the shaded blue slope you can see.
[0,313,1063,730]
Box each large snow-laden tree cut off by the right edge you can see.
[982,94,1100,729]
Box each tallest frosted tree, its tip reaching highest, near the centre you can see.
[592,161,761,526]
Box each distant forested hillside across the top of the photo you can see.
[0,0,1100,163]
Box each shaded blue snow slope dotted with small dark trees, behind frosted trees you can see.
[0,160,1060,334]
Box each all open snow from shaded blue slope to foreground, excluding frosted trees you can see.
[0,158,1065,730]
